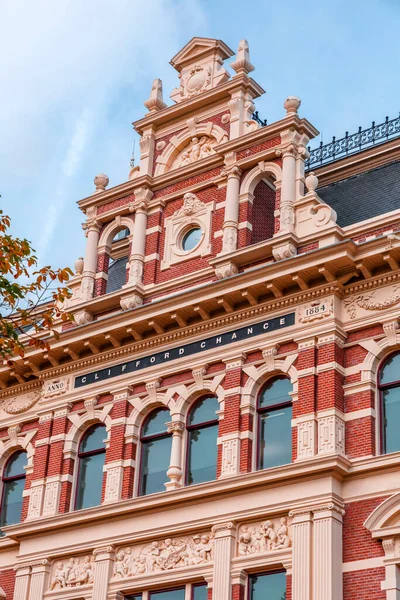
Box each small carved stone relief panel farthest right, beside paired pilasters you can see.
[237,517,292,556]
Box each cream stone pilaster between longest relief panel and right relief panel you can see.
[212,522,236,600]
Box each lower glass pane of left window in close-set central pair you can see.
[140,434,171,496]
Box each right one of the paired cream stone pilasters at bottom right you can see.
[313,502,344,600]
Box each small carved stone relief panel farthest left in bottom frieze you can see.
[49,555,94,591]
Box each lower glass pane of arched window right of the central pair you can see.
[259,406,292,469]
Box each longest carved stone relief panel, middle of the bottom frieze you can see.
[113,533,214,579]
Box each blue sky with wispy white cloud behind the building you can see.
[0,0,400,267]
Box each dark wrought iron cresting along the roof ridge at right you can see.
[306,114,400,170]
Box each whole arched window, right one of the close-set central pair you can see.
[186,396,219,485]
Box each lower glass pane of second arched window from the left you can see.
[76,452,105,510]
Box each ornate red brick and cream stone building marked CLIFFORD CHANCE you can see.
[0,38,400,600]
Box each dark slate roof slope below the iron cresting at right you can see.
[317,162,400,227]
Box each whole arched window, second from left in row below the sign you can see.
[75,425,107,510]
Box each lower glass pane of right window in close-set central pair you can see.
[187,425,218,485]
